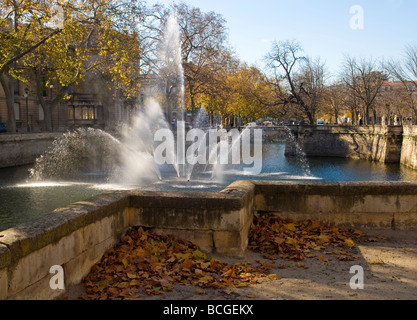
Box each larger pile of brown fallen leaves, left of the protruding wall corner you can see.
[80,228,277,300]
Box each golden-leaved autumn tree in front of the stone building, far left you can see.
[2,0,143,131]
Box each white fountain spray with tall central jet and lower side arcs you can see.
[31,14,262,186]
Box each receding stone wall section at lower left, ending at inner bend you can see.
[0,193,129,300]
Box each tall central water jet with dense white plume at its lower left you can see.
[114,14,185,183]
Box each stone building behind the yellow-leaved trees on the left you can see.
[0,75,141,133]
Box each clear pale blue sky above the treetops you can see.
[147,0,417,75]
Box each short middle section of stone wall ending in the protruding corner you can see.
[130,181,255,254]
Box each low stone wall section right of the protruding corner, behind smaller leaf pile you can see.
[254,181,417,230]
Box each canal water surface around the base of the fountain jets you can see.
[0,143,417,231]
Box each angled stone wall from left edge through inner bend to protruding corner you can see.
[0,181,254,300]
